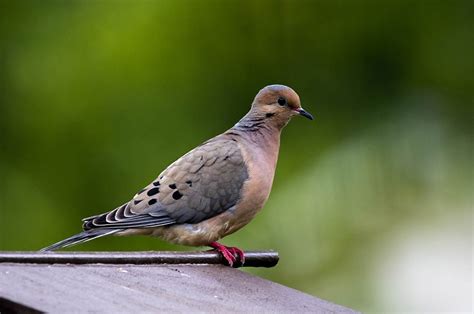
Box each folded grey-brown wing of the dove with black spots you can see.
[83,135,248,230]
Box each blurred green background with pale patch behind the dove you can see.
[0,0,474,312]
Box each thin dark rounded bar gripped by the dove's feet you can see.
[0,251,279,267]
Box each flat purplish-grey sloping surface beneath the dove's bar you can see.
[0,253,354,313]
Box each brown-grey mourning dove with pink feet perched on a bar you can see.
[40,84,313,267]
